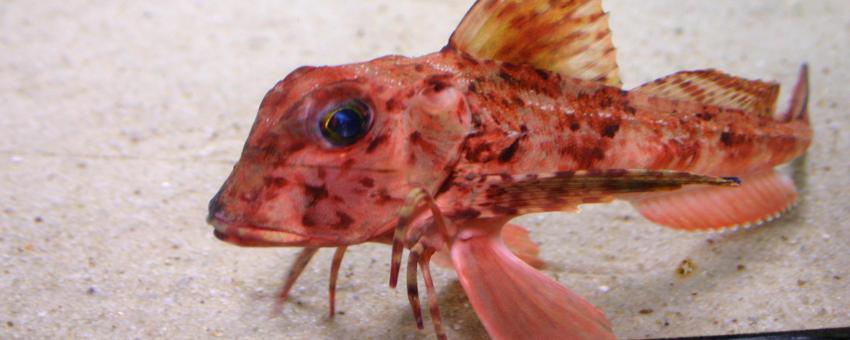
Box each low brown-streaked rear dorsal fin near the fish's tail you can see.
[634,70,779,116]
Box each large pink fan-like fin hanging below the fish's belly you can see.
[452,228,615,339]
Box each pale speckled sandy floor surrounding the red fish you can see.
[0,0,850,339]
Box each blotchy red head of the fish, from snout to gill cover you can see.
[207,57,470,247]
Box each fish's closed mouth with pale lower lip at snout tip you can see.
[207,212,308,247]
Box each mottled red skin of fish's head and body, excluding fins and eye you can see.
[209,48,812,250]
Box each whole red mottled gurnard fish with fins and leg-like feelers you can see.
[208,0,812,339]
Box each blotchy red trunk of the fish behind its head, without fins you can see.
[441,51,812,176]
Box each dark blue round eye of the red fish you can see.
[319,101,369,146]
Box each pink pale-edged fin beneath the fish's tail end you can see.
[632,170,797,231]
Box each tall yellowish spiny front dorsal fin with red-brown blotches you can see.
[449,0,621,87]
